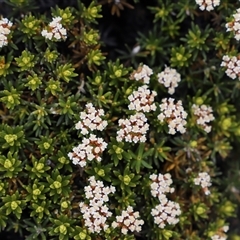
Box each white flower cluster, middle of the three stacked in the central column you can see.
[128,85,157,112]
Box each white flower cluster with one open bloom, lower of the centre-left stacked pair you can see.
[68,134,107,167]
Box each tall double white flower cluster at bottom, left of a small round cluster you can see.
[79,176,116,233]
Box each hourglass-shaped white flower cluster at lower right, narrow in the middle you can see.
[150,173,181,228]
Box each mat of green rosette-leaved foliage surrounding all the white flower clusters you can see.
[0,0,240,240]
